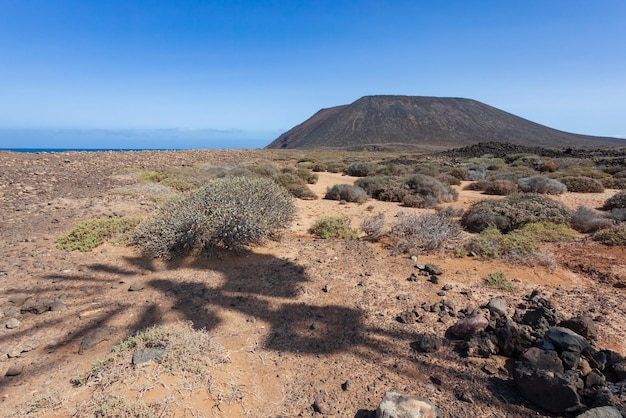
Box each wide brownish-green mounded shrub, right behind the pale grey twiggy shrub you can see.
[461,193,571,232]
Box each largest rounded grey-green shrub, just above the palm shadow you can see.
[130,177,295,258]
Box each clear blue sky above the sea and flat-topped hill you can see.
[0,0,626,148]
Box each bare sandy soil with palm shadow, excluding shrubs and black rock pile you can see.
[0,151,626,417]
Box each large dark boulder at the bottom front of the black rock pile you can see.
[513,361,580,414]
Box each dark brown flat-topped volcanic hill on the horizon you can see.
[267,96,626,149]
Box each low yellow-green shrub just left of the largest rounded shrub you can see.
[55,217,139,252]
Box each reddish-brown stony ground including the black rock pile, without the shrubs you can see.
[0,150,626,417]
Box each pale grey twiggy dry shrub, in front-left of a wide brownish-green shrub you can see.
[389,212,462,254]
